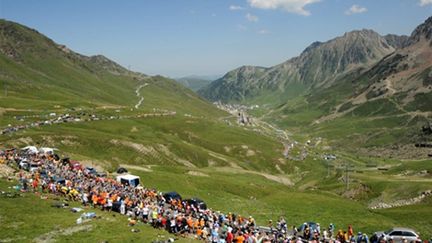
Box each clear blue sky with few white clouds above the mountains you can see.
[0,0,432,77]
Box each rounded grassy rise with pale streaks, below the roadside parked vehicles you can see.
[0,115,283,172]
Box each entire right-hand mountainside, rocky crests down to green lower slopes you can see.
[198,17,432,158]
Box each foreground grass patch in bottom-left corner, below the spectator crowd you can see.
[0,179,193,242]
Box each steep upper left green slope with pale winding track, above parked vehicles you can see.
[0,20,222,116]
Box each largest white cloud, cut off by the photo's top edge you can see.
[248,0,321,16]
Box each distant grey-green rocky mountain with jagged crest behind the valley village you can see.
[198,30,394,103]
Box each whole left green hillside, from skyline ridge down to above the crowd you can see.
[0,20,286,171]
